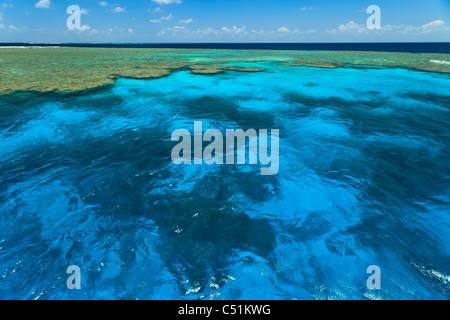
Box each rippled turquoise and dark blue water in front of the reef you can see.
[0,62,450,299]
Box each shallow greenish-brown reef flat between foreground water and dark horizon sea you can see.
[0,47,450,94]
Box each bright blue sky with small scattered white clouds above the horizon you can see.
[0,0,450,43]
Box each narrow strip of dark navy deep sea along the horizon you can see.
[1,42,450,53]
